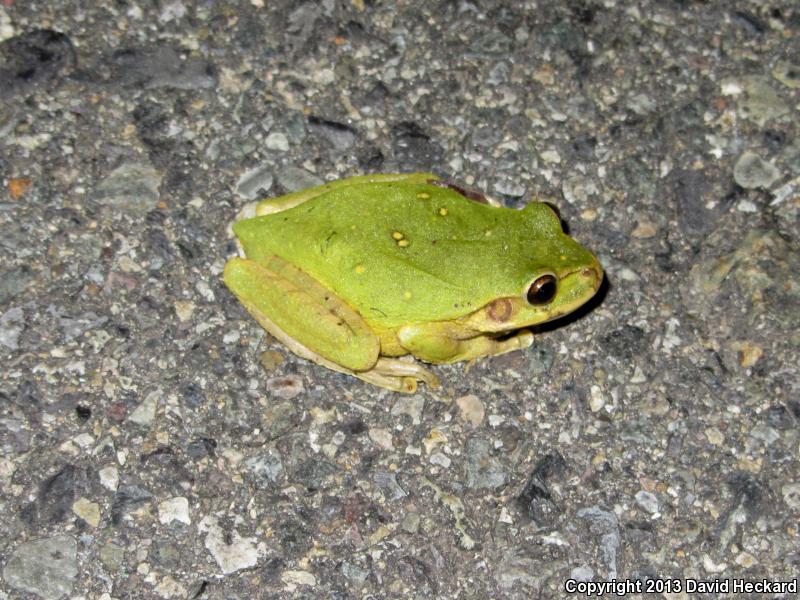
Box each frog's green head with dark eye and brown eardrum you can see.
[463,202,603,333]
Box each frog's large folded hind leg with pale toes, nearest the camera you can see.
[224,256,439,393]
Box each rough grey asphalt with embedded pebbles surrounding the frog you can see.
[0,0,800,599]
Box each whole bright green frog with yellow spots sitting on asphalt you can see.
[223,173,604,393]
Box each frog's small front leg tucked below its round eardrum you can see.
[397,322,533,363]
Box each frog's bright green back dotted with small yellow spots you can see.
[235,182,560,326]
